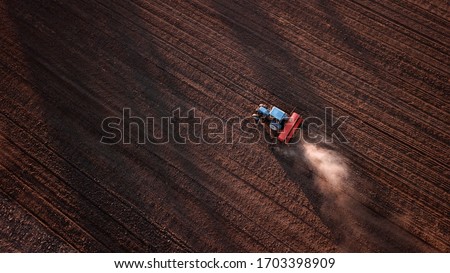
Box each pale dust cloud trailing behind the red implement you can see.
[301,143,429,252]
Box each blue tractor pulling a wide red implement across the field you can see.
[252,104,303,144]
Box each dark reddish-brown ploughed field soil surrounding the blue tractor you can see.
[0,0,450,252]
